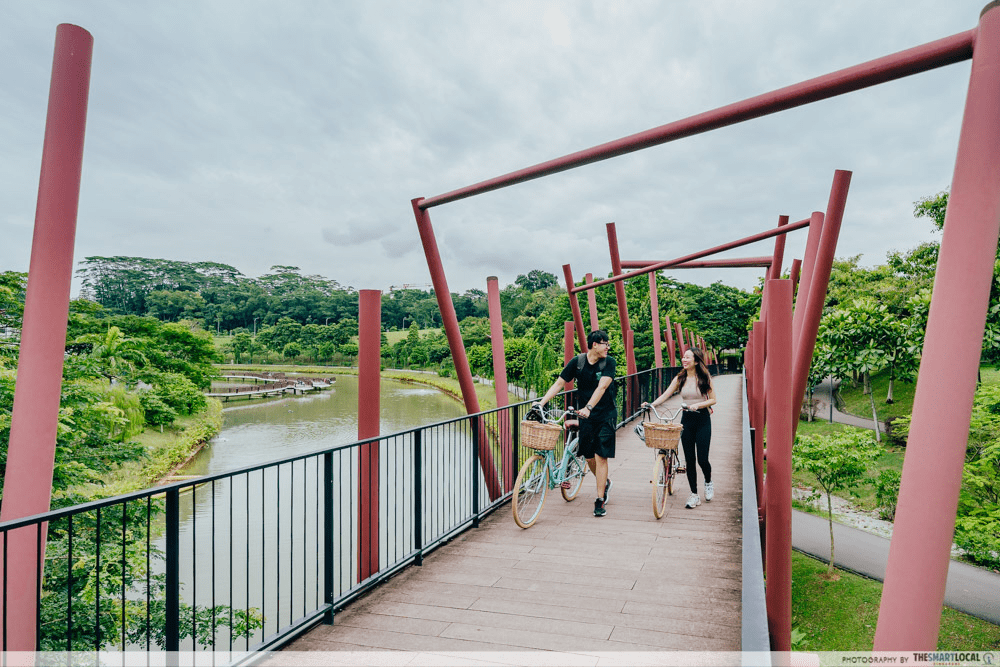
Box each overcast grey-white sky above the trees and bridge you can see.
[0,0,986,294]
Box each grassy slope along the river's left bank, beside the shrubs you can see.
[74,398,222,498]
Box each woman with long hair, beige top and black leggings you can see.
[652,347,715,509]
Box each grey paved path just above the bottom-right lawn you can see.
[792,511,1000,625]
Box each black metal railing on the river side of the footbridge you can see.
[0,367,736,654]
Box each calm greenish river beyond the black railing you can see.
[158,376,485,650]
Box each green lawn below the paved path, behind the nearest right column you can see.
[792,551,1000,651]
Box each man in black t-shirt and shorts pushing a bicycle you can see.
[537,329,617,516]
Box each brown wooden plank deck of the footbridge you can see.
[268,376,742,665]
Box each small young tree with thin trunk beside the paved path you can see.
[792,431,880,575]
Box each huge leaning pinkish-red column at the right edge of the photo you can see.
[875,2,1000,651]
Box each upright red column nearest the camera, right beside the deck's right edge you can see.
[764,280,792,651]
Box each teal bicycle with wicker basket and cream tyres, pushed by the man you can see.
[511,406,587,528]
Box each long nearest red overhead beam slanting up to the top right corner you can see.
[420,30,976,209]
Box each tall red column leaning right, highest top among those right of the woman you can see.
[792,174,851,444]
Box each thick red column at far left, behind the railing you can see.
[0,23,94,651]
